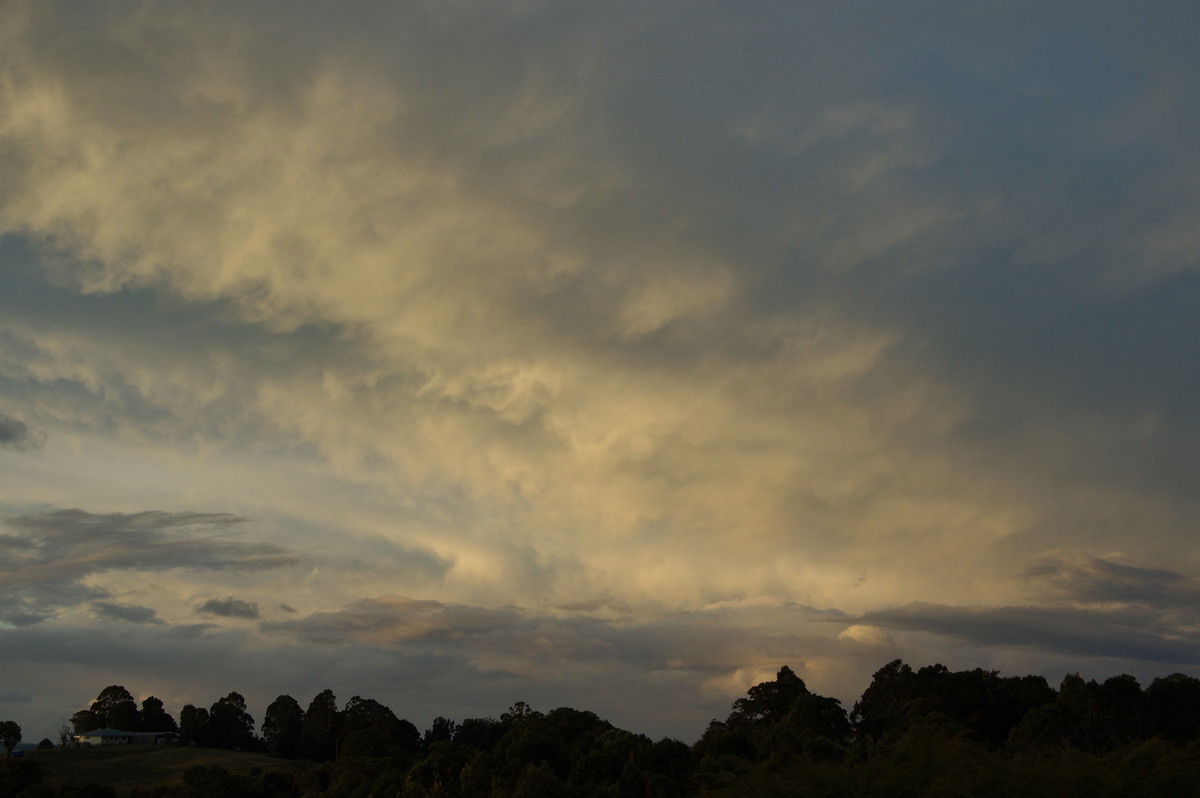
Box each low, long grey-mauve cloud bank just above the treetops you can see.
[0,596,881,742]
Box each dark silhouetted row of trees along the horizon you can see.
[4,660,1200,798]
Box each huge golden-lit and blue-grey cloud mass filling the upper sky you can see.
[0,4,1200,624]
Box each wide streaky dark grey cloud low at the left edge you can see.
[0,510,298,626]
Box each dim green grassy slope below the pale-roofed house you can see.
[26,745,317,796]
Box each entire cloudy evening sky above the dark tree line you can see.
[0,0,1200,743]
